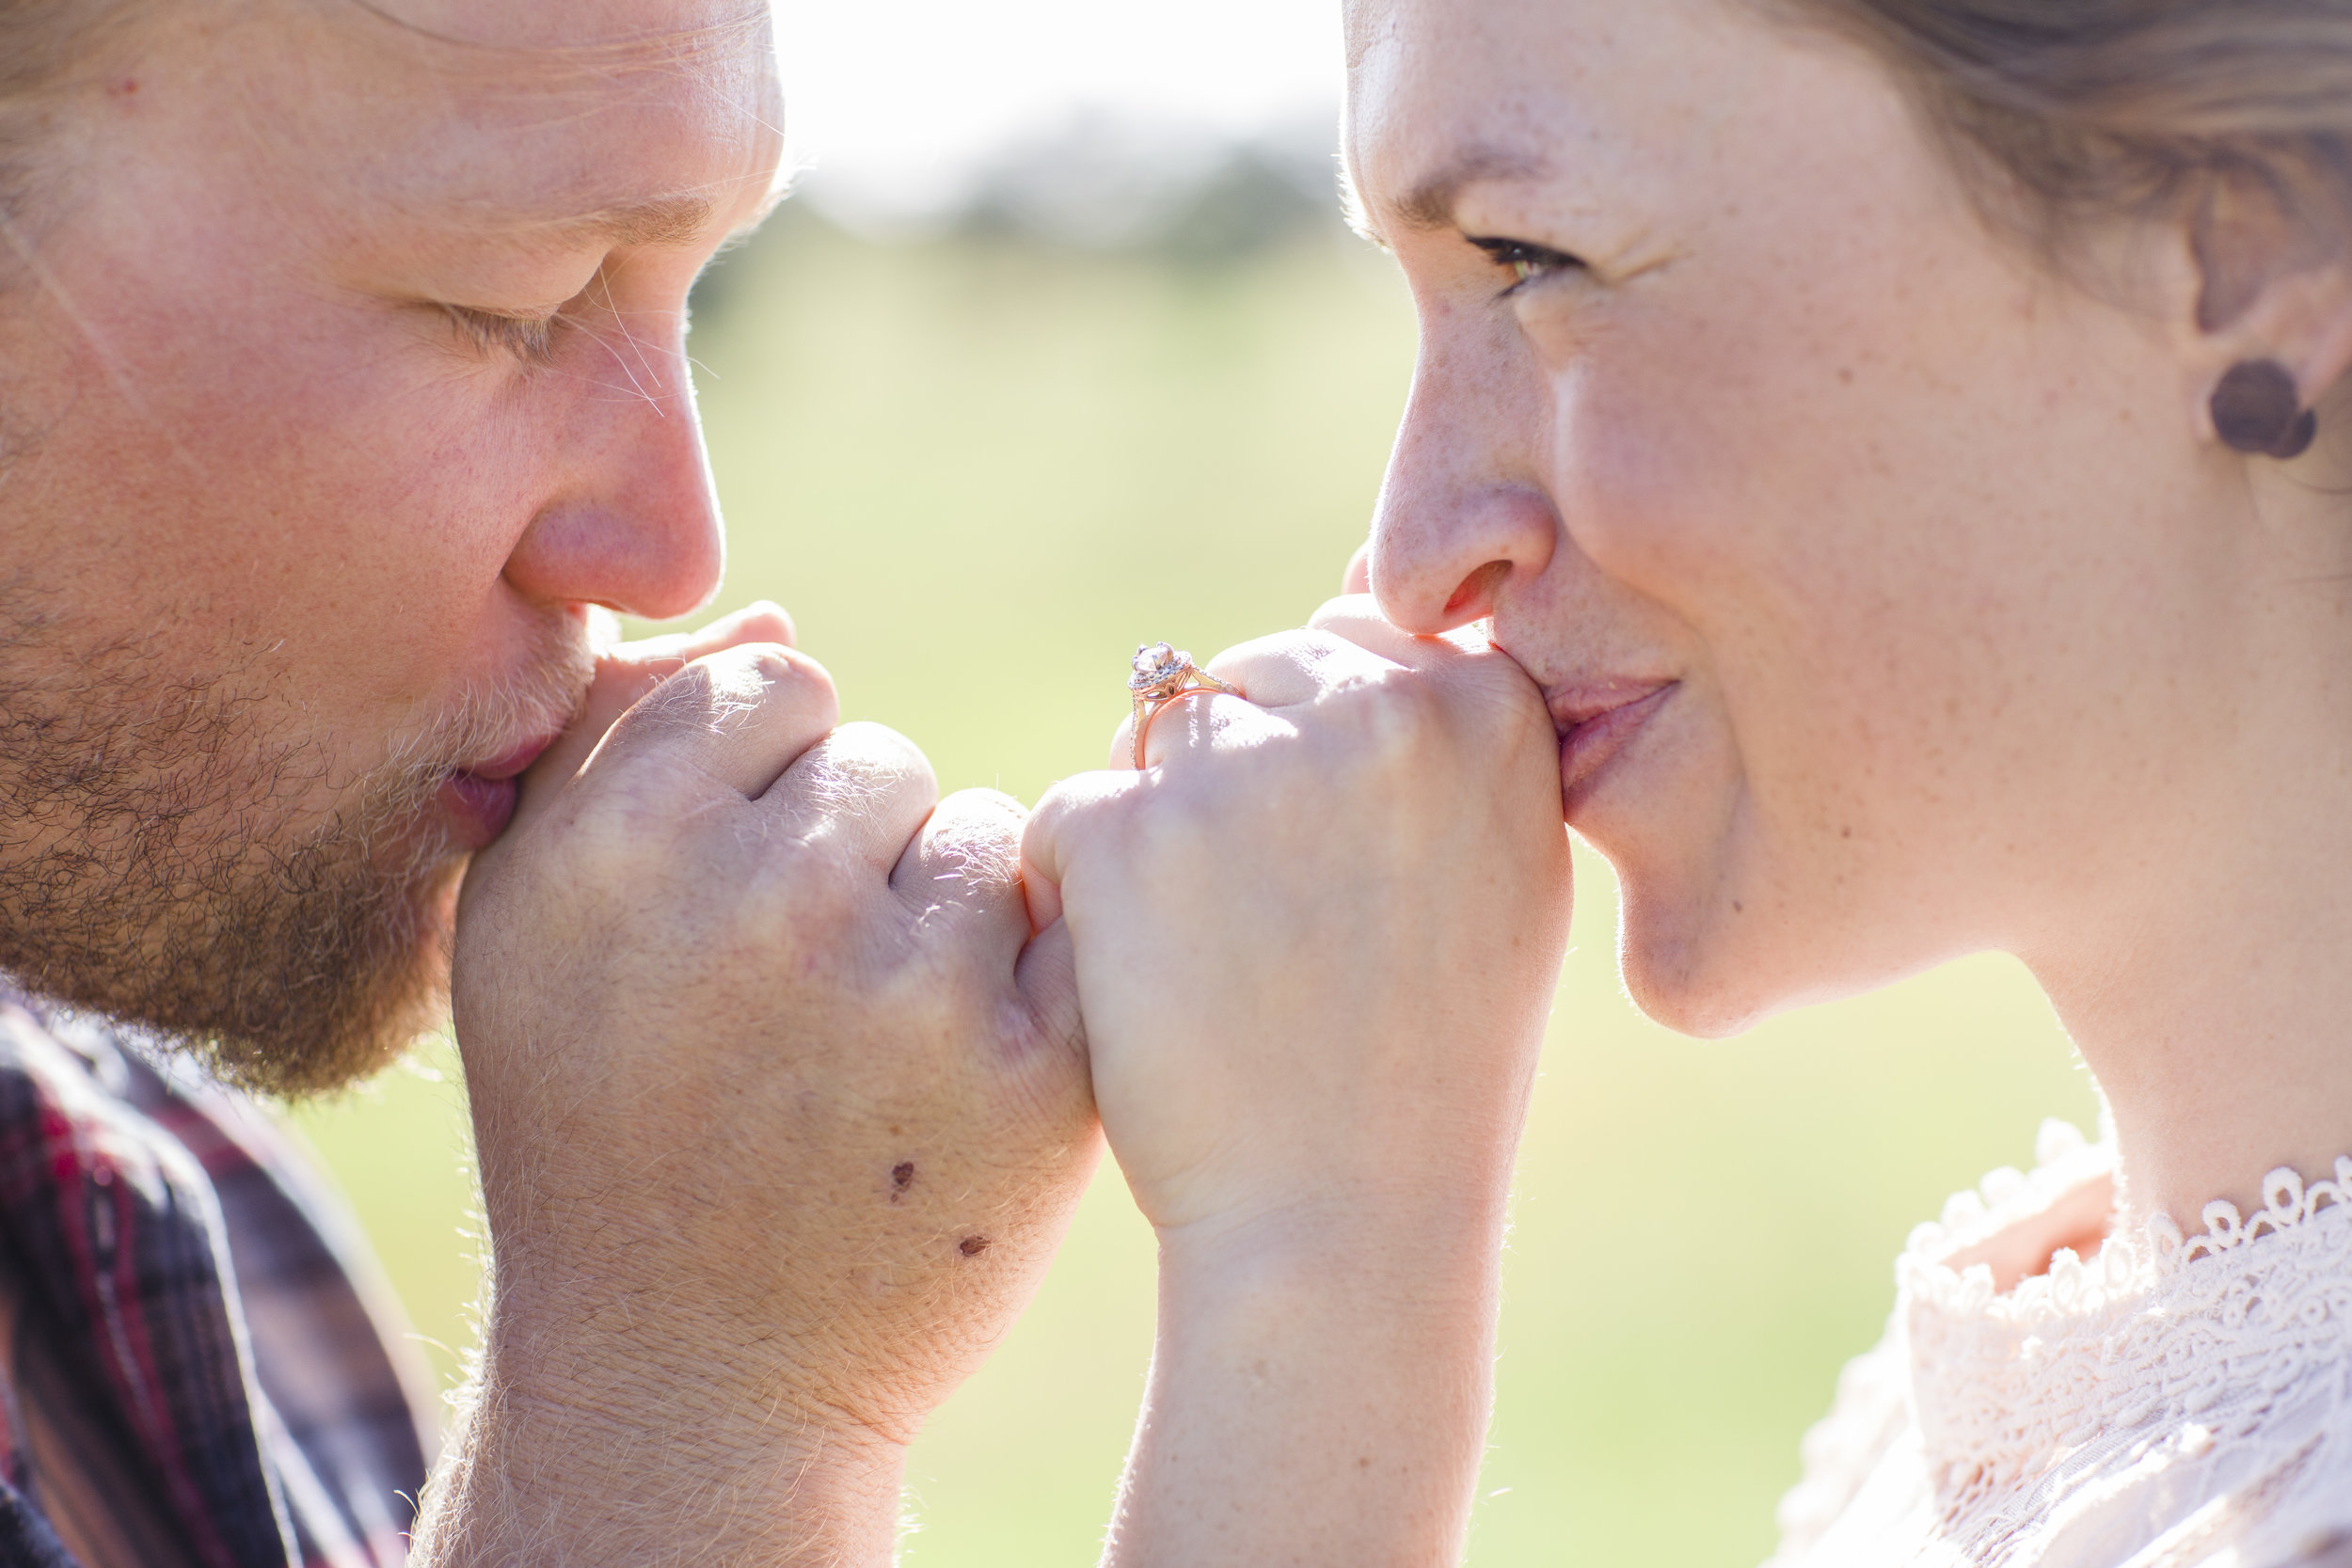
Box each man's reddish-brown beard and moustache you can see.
[0,607,593,1096]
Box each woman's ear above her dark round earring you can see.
[2190,174,2352,422]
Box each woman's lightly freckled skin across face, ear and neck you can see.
[1345,0,2352,1215]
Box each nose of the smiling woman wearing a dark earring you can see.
[1372,320,1560,632]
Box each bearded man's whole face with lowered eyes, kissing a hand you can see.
[0,0,781,1088]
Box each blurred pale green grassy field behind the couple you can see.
[279,204,2091,1568]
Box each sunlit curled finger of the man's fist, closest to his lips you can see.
[583,641,842,800]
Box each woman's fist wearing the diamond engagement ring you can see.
[1028,599,1569,1275]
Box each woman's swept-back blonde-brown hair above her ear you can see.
[1772,0,2352,257]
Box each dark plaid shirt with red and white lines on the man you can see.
[0,990,431,1568]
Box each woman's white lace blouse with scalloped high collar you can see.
[1773,1121,2352,1568]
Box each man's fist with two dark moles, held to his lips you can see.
[454,620,1099,1444]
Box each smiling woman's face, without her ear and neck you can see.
[1348,0,2244,1032]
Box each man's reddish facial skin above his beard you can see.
[0,2,757,846]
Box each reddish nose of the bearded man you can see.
[506,322,727,621]
